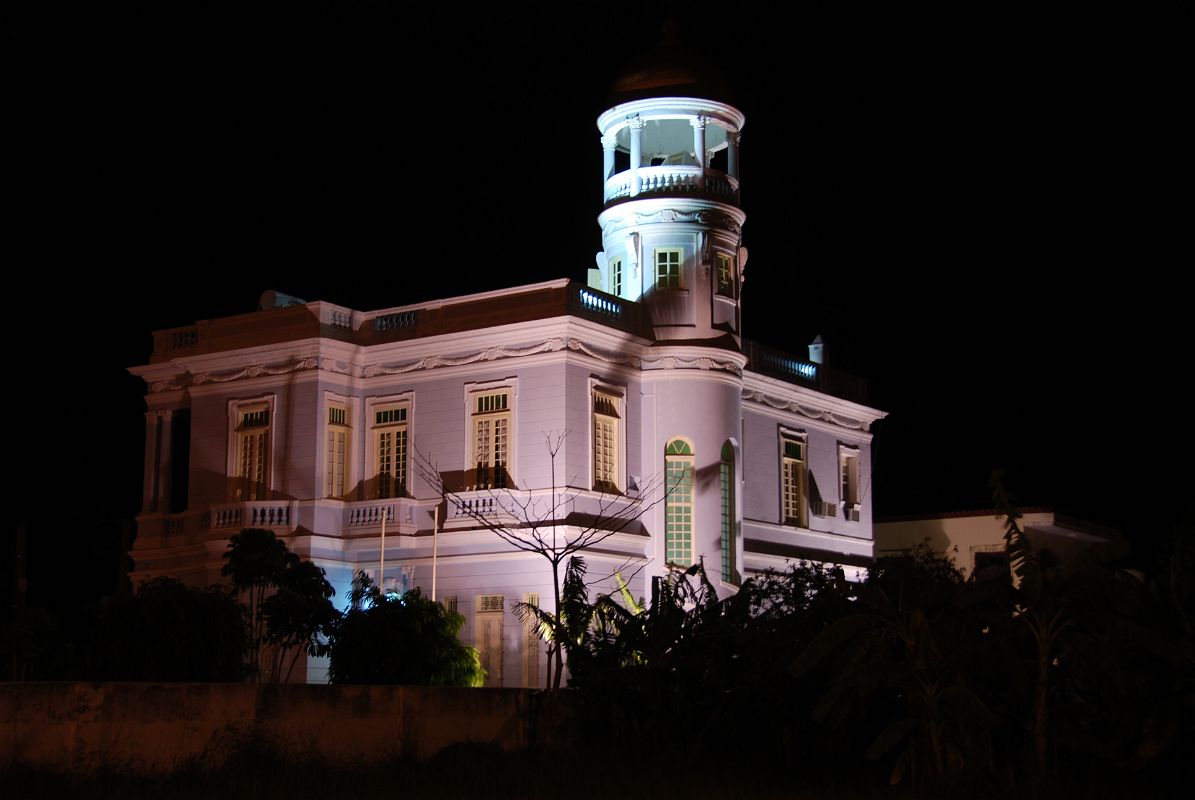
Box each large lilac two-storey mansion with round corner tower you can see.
[131,63,884,686]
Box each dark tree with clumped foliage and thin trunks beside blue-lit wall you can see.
[220,527,336,680]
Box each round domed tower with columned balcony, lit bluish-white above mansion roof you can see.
[589,33,747,349]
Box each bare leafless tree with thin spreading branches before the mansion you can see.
[415,430,668,689]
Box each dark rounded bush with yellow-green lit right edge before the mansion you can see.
[329,573,485,686]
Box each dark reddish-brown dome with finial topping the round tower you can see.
[609,20,734,106]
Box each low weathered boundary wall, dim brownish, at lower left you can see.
[0,683,566,772]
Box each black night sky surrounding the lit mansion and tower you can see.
[6,4,1191,581]
